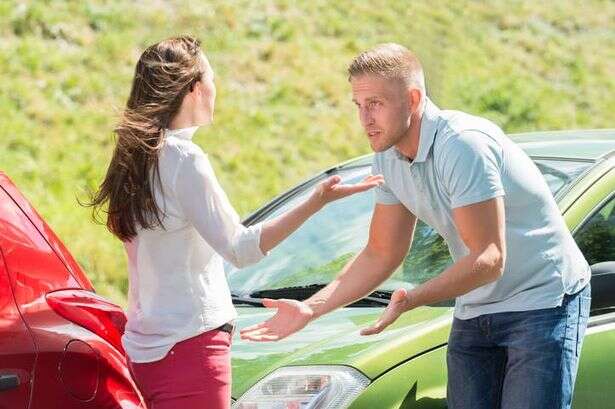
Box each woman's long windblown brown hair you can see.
[85,36,205,241]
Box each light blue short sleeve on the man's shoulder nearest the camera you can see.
[437,131,505,208]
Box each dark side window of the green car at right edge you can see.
[575,196,615,265]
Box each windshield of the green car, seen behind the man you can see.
[227,159,591,296]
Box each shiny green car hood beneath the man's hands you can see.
[232,307,453,398]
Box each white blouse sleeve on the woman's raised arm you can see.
[173,151,266,268]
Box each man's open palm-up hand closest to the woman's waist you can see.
[240,298,314,342]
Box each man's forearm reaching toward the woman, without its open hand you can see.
[305,248,401,319]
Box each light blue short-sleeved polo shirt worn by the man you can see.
[373,100,591,319]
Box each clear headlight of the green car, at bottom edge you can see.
[233,366,369,409]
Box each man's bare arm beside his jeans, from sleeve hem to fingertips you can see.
[361,197,506,335]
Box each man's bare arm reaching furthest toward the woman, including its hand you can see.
[241,204,416,341]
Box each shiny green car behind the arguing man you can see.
[228,130,615,409]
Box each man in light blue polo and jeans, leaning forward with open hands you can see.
[242,44,590,409]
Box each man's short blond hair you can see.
[348,43,425,94]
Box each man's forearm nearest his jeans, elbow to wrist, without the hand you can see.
[408,244,504,309]
